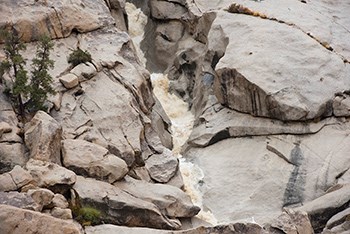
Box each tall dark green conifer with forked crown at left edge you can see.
[0,30,55,119]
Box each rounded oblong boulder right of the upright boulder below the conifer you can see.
[62,140,128,183]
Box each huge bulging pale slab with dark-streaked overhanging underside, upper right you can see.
[209,12,349,120]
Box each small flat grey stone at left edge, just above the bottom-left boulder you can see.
[0,192,42,211]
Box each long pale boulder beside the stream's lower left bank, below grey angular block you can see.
[114,177,200,218]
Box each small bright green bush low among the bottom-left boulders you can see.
[73,207,101,226]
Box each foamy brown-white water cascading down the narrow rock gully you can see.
[126,3,217,225]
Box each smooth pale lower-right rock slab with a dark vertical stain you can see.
[184,122,350,223]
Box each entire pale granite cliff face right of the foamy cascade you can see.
[137,0,350,233]
